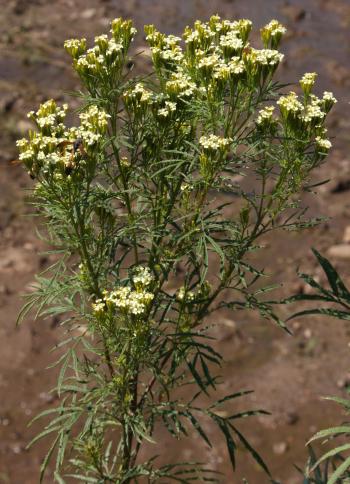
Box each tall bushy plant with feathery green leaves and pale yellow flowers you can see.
[18,16,335,483]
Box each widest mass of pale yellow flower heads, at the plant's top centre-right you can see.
[145,15,285,91]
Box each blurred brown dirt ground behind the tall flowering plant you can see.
[0,0,350,484]
